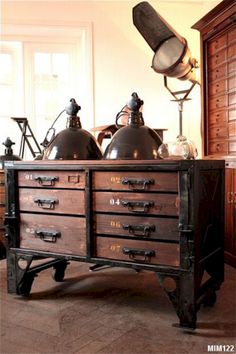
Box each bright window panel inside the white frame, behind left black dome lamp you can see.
[24,43,79,142]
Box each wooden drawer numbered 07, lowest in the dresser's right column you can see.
[95,237,179,267]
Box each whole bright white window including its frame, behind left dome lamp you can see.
[0,25,94,158]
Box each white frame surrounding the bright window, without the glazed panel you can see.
[1,22,95,154]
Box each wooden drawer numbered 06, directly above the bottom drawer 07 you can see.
[94,214,179,241]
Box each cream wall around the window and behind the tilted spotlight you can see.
[1,0,219,155]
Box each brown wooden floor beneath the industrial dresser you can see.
[0,260,236,354]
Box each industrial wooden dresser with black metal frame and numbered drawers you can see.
[5,160,224,328]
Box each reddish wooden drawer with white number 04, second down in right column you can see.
[93,192,179,216]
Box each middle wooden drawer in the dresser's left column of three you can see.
[19,188,85,215]
